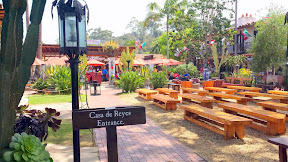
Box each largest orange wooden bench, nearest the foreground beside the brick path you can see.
[181,105,252,140]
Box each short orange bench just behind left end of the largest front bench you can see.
[179,93,216,109]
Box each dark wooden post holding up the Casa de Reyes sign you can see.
[106,126,118,162]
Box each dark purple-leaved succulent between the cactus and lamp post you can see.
[14,108,62,141]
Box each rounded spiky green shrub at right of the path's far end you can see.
[116,72,144,92]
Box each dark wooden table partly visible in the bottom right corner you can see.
[268,136,288,162]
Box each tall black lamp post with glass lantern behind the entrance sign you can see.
[52,0,89,162]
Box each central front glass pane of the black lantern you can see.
[65,14,77,47]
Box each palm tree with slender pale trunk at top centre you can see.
[144,0,187,58]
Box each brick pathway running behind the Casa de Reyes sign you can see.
[89,84,205,162]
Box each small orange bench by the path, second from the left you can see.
[151,94,180,110]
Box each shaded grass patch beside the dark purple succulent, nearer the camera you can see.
[44,119,94,147]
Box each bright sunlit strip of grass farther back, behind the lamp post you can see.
[28,94,86,105]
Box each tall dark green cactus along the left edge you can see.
[0,0,46,154]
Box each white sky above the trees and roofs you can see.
[23,0,288,44]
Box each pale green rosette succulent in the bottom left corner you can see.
[3,133,53,162]
